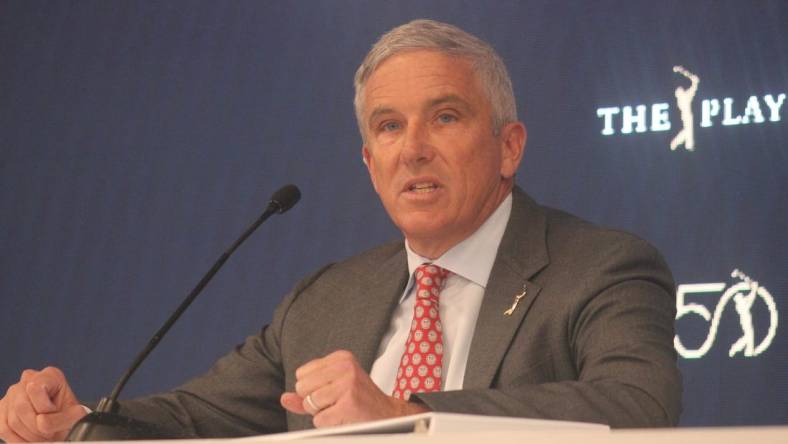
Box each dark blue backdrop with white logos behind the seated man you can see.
[0,0,788,425]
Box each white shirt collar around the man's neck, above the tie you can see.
[405,193,512,295]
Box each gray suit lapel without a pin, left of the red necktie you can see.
[326,248,408,372]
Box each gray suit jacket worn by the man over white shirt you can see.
[122,189,681,437]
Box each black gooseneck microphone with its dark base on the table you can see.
[66,185,301,441]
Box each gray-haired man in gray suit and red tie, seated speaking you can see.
[0,20,681,441]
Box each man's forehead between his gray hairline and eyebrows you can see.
[363,50,486,115]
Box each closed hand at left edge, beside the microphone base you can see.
[0,367,86,442]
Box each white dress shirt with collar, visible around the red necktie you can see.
[370,193,512,395]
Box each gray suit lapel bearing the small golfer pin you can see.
[463,188,549,389]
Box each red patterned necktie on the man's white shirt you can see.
[392,264,449,400]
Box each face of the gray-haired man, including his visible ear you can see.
[362,51,525,258]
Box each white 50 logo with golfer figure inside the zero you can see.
[673,270,778,359]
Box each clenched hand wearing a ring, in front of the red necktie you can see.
[280,350,429,428]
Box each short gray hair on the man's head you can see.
[353,19,517,139]
